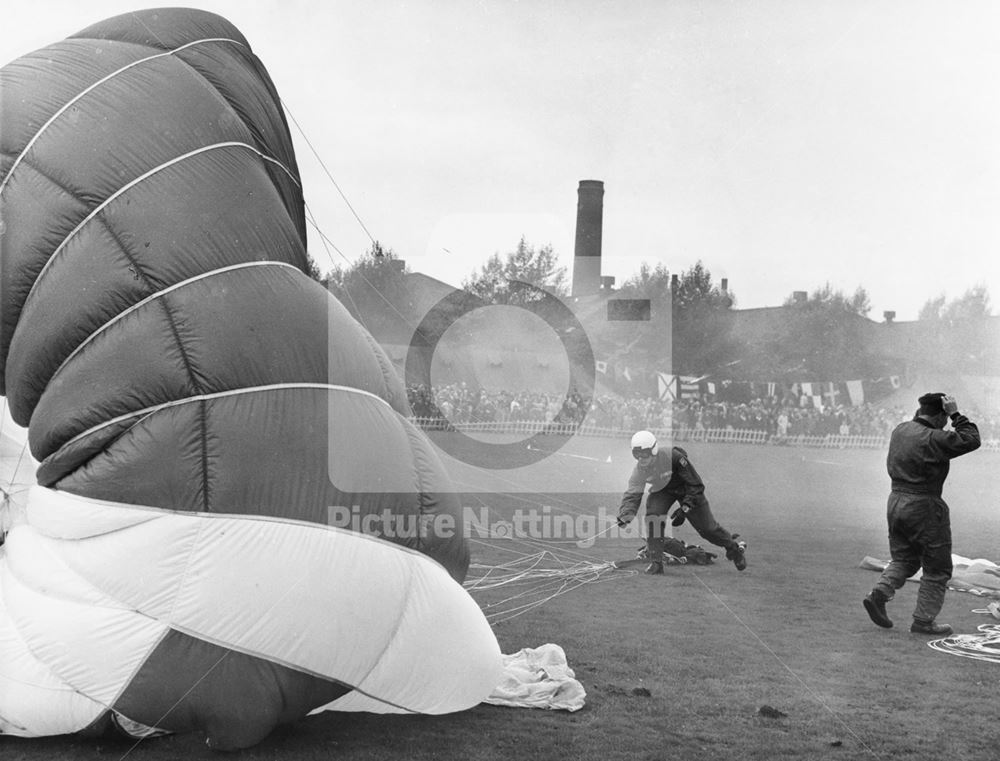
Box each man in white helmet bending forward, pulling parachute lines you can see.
[618,431,747,574]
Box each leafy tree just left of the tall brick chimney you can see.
[462,236,569,304]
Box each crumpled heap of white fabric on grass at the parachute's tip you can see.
[483,644,587,711]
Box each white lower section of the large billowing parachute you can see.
[0,486,501,736]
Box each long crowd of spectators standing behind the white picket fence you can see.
[407,383,1000,443]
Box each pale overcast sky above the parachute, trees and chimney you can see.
[0,0,1000,320]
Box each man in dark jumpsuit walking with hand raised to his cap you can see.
[864,393,980,636]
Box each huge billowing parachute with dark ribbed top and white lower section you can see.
[0,9,500,748]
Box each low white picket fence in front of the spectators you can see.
[410,418,1000,452]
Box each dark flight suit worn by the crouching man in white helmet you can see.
[618,447,737,561]
